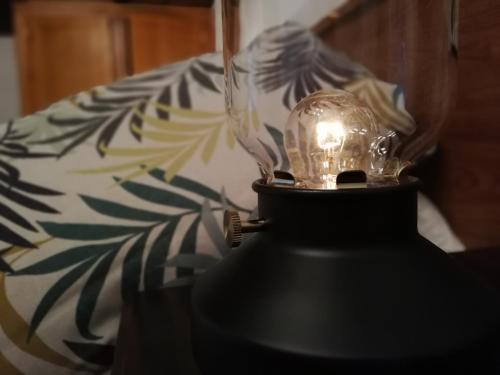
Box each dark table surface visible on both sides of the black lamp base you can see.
[112,247,500,375]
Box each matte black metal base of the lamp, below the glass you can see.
[192,181,500,375]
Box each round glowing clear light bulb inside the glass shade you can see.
[285,89,400,189]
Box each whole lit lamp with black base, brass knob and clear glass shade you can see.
[192,0,500,374]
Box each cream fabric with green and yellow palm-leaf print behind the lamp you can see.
[0,25,463,374]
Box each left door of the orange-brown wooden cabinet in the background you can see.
[15,2,127,114]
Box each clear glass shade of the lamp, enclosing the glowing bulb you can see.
[222,0,457,189]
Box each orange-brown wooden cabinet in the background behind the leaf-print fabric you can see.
[14,0,214,114]
